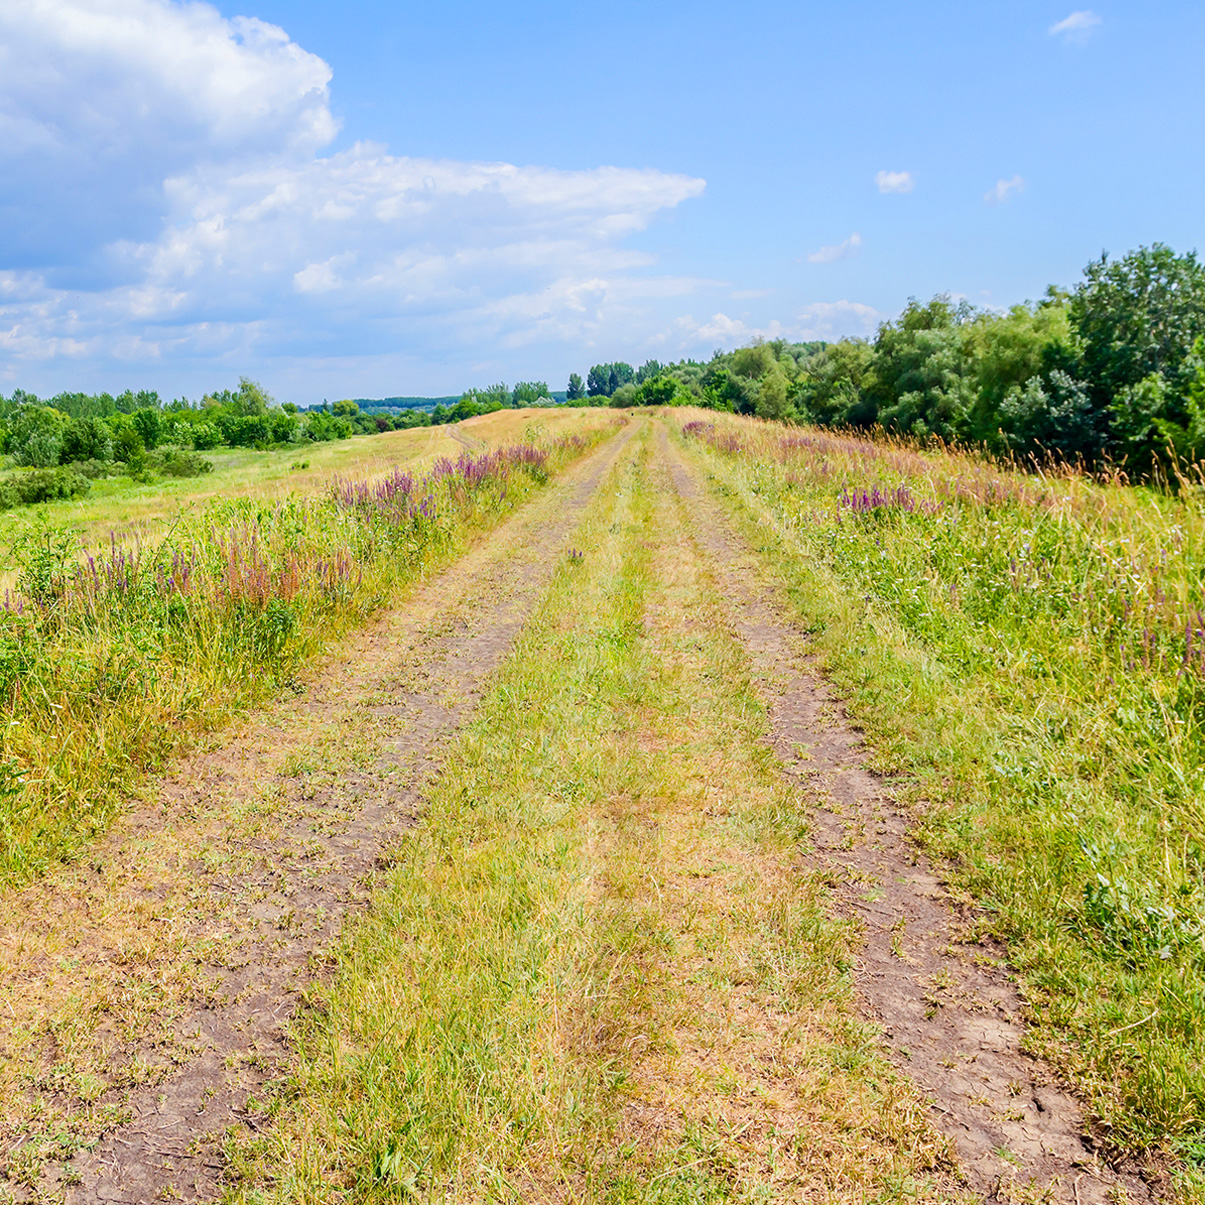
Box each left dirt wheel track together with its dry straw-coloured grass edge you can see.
[0,426,628,1203]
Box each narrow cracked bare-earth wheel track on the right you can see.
[660,430,1158,1205]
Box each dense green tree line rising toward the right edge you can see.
[570,243,1205,477]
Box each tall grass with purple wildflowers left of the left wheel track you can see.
[0,431,600,884]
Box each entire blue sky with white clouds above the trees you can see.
[0,0,1205,405]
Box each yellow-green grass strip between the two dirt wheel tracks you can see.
[230,426,958,1205]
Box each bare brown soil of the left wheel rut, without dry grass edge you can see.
[11,425,633,1205]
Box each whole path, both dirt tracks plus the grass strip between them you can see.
[0,419,1180,1205]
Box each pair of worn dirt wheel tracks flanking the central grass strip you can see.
[0,424,1153,1205]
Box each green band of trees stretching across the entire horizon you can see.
[0,243,1205,482]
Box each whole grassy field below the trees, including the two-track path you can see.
[0,407,1205,1205]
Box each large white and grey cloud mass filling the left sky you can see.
[0,0,704,390]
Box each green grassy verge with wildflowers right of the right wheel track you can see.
[684,415,1205,1171]
